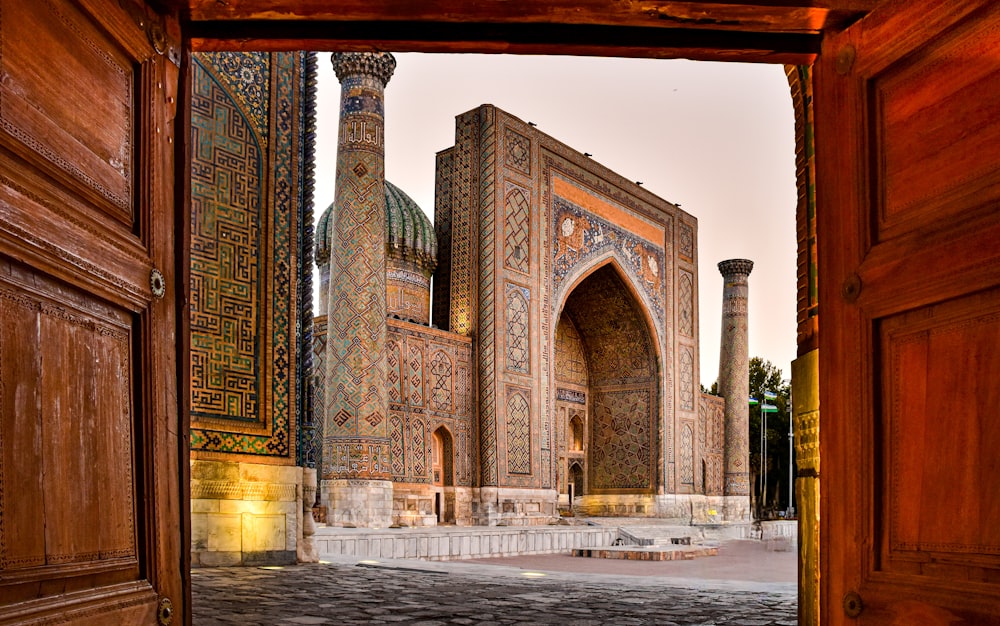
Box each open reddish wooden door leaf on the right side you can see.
[814,0,1000,624]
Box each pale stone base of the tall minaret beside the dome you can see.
[320,478,392,528]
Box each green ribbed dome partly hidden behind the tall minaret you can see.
[316,181,437,273]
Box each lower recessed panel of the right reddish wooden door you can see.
[875,289,1000,572]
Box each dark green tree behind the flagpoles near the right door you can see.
[750,357,791,518]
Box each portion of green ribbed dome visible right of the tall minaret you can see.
[385,181,437,275]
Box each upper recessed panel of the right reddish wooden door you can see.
[870,12,1000,241]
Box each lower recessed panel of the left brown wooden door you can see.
[0,260,141,600]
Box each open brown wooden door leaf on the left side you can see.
[0,0,187,624]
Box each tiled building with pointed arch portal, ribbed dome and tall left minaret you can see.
[313,53,747,525]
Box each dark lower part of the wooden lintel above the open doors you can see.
[188,19,820,64]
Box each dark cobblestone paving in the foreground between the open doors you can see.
[192,563,796,626]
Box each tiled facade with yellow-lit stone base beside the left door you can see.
[183,52,317,565]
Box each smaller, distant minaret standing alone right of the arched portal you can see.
[719,259,753,521]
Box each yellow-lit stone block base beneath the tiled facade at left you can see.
[191,459,317,567]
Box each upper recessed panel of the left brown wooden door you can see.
[0,0,135,226]
